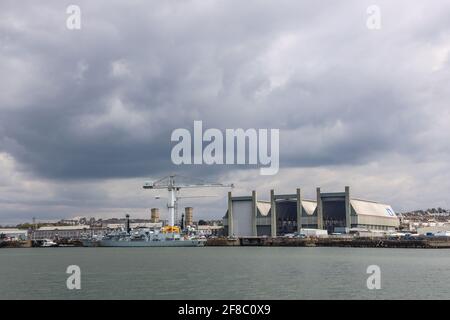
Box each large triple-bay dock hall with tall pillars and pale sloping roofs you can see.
[223,187,399,237]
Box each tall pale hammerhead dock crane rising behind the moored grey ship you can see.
[144,174,234,226]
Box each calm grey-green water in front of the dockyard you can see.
[0,247,450,299]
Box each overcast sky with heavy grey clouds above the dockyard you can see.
[0,0,450,225]
